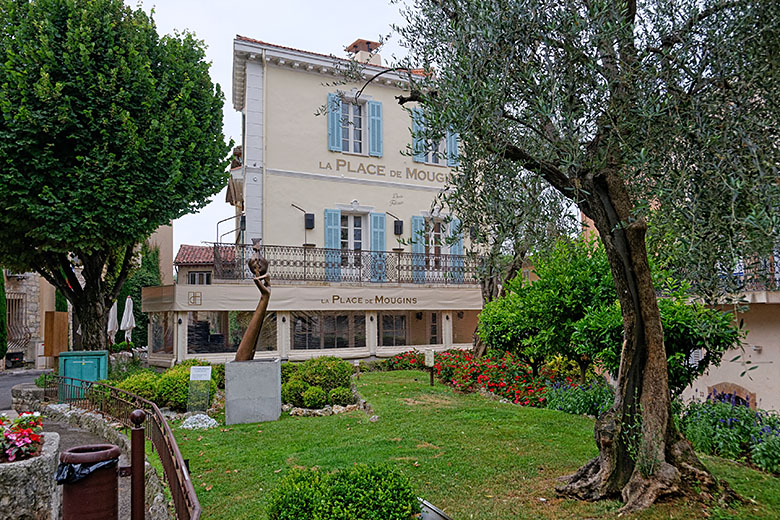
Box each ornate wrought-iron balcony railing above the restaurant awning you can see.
[207,244,479,286]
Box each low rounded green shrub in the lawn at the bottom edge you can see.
[267,464,420,520]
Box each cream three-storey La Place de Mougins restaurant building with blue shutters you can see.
[143,37,482,365]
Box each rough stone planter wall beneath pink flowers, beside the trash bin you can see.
[0,432,62,520]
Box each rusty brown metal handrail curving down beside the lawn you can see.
[44,374,201,520]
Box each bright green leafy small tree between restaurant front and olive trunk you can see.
[479,239,617,382]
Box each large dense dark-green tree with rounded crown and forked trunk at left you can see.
[0,0,230,348]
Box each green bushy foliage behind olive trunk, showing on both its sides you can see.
[571,293,743,397]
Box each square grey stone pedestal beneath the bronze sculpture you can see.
[225,359,282,424]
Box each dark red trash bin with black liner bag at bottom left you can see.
[54,444,120,520]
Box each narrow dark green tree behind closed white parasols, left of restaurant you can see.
[117,242,162,346]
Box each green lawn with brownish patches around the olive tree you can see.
[175,371,780,520]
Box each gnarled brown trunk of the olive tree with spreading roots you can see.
[557,171,719,511]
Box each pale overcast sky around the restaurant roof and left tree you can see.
[125,0,403,256]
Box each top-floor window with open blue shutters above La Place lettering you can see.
[328,93,382,157]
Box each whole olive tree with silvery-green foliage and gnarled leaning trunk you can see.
[399,0,780,510]
